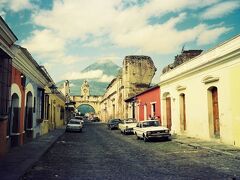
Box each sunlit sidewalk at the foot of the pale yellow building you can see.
[173,135,240,160]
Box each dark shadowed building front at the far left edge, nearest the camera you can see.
[0,16,17,156]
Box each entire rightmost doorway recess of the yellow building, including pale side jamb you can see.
[207,86,220,138]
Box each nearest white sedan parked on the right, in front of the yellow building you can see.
[134,120,171,142]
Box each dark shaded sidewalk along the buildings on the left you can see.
[0,127,65,180]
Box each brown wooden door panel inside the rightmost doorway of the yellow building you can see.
[212,87,220,136]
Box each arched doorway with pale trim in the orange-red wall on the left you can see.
[8,93,20,147]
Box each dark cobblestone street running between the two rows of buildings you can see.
[21,124,240,180]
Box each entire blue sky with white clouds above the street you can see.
[0,0,240,83]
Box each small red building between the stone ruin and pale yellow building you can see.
[126,85,161,123]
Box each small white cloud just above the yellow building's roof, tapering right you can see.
[197,27,231,45]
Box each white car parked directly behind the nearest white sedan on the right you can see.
[118,118,137,134]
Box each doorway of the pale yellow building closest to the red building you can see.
[162,92,172,130]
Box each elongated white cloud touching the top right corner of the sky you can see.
[201,1,240,19]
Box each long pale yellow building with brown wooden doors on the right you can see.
[160,35,240,146]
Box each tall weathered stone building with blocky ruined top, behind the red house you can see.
[100,56,156,121]
